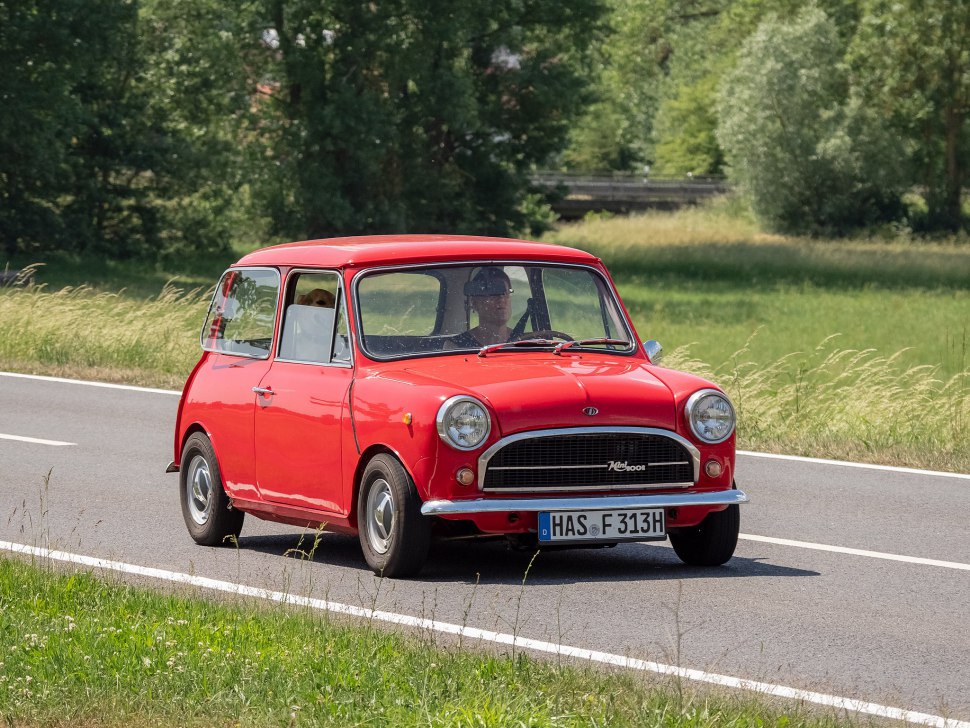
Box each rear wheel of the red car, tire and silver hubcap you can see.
[179,432,246,546]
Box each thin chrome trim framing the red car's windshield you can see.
[350,258,639,362]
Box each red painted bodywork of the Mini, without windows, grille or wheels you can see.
[174,235,735,544]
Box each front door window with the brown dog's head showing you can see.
[278,273,350,364]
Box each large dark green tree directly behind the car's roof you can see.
[250,0,600,237]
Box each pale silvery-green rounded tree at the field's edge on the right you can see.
[718,7,902,234]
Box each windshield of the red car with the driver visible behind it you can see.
[357,264,634,359]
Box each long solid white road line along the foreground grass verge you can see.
[0,541,970,728]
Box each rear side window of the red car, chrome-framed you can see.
[202,269,280,359]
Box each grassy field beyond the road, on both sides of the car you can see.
[0,203,970,472]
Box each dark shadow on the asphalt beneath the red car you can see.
[239,533,820,585]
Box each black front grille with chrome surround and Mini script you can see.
[478,427,700,493]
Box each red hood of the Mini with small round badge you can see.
[379,352,676,435]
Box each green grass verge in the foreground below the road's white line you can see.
[0,559,844,728]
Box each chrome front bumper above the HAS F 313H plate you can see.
[421,490,749,516]
